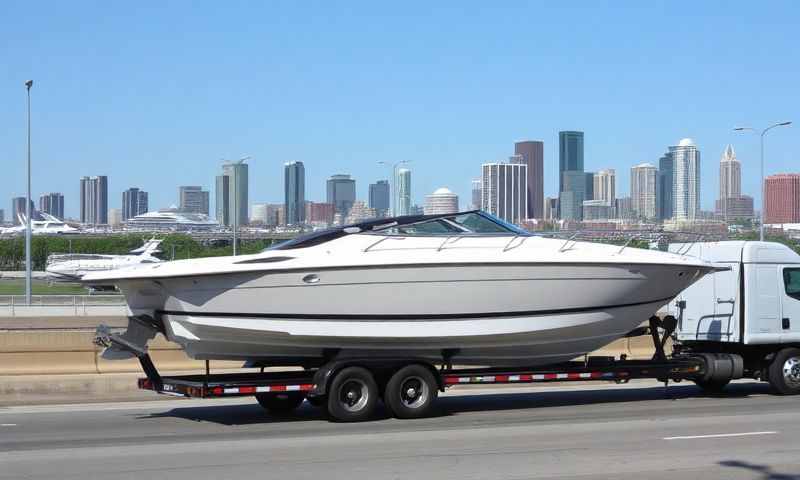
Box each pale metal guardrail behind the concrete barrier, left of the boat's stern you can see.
[0,295,126,317]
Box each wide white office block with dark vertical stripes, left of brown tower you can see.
[481,163,528,223]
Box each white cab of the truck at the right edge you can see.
[667,241,800,393]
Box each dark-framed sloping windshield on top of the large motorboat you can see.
[266,210,531,250]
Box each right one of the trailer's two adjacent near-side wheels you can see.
[383,365,439,418]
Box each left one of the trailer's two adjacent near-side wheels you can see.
[328,367,378,422]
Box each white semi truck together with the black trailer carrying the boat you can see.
[96,241,800,421]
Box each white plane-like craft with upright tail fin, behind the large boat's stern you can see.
[45,238,161,282]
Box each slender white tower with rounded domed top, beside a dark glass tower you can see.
[669,138,700,222]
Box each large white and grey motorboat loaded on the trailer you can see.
[84,211,714,366]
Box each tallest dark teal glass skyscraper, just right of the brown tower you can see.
[558,131,588,220]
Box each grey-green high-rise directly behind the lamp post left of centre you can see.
[215,160,250,226]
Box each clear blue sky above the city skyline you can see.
[0,1,800,216]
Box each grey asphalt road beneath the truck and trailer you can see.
[0,382,800,480]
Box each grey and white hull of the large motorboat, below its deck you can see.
[123,263,705,366]
